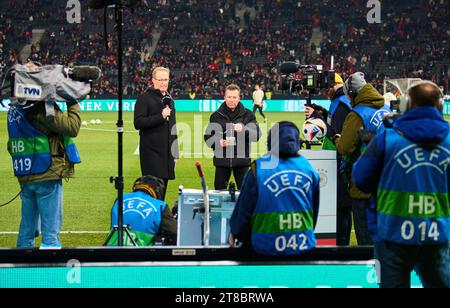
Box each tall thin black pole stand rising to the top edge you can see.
[89,0,140,247]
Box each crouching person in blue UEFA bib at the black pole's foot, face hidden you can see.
[106,175,177,246]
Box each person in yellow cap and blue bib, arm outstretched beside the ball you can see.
[305,73,352,246]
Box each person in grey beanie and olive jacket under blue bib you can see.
[335,72,391,245]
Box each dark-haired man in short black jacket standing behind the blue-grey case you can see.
[204,84,261,190]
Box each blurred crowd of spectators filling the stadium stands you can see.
[0,0,450,98]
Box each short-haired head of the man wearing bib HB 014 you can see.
[408,82,442,108]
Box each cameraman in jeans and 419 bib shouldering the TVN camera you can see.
[8,63,84,248]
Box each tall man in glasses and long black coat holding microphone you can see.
[134,67,179,200]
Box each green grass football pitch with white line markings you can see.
[0,112,450,247]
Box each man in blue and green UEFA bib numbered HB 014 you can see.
[353,81,450,288]
